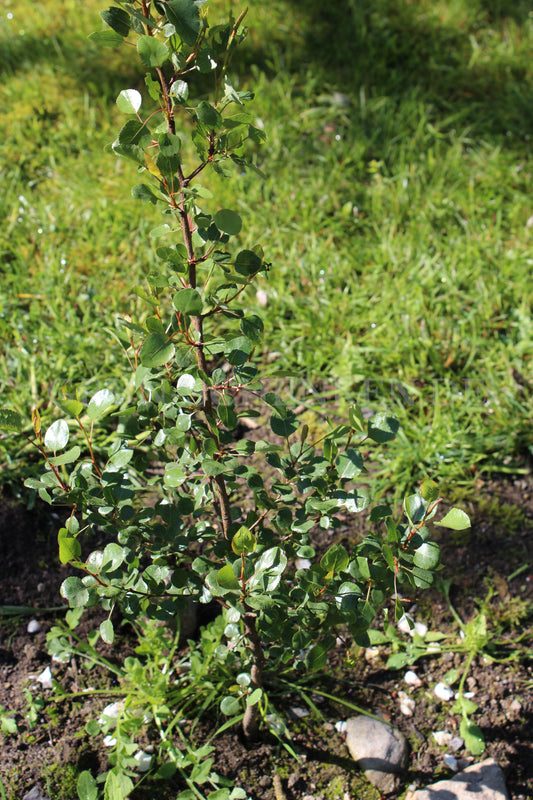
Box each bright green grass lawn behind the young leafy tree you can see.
[0,0,533,488]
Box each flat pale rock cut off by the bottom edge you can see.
[405,758,509,800]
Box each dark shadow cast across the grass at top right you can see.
[241,0,533,138]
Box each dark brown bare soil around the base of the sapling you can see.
[0,476,533,800]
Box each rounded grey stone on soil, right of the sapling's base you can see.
[346,716,408,800]
